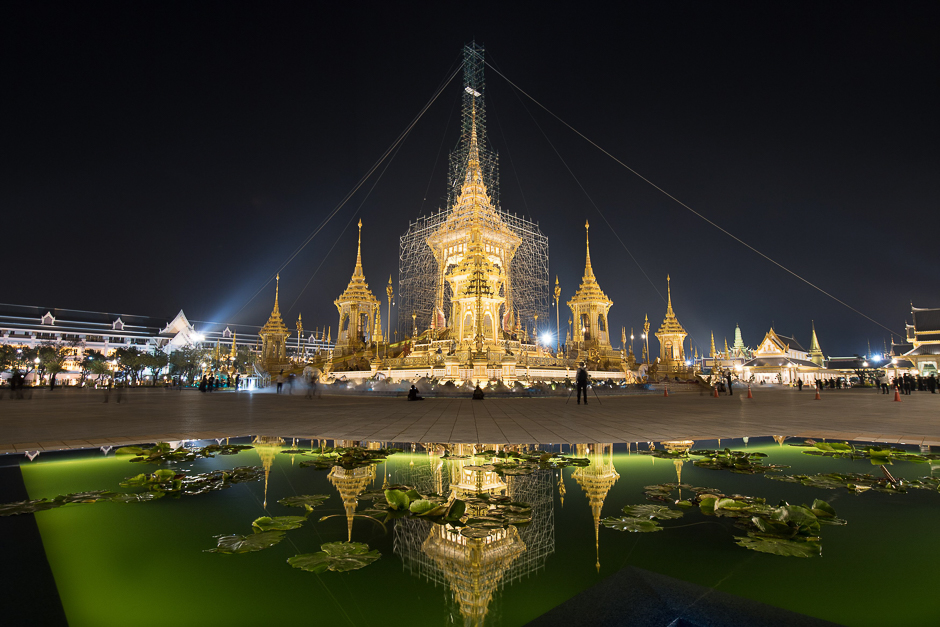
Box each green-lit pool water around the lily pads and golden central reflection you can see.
[12,438,940,627]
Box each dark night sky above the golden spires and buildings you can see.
[0,1,940,355]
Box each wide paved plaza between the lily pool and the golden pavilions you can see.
[0,387,940,454]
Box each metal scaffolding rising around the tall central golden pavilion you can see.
[398,43,549,337]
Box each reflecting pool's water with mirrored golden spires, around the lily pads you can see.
[0,436,940,627]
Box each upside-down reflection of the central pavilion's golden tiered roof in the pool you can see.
[421,525,525,626]
